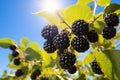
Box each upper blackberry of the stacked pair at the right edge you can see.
[104,13,119,27]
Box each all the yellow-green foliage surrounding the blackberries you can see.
[0,0,120,80]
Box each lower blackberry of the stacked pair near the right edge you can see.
[102,27,116,39]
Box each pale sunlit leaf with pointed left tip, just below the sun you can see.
[35,9,67,29]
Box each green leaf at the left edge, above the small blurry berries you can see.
[0,38,16,48]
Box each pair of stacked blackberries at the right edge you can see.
[102,13,119,39]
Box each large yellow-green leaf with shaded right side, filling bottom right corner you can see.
[94,50,120,80]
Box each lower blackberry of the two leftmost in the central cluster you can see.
[43,40,56,53]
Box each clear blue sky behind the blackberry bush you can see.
[0,0,120,75]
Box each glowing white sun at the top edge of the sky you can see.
[42,0,60,12]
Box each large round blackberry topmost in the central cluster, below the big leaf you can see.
[72,20,89,36]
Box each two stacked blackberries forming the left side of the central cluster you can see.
[41,25,58,53]
